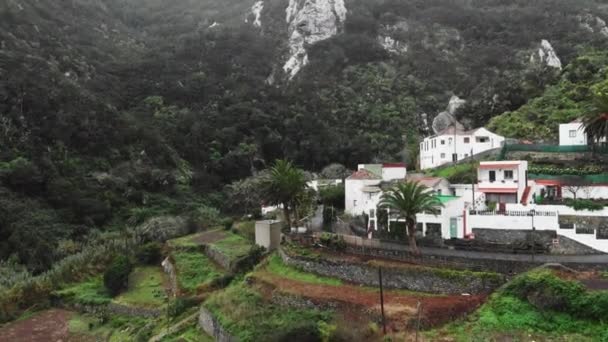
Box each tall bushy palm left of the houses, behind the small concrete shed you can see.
[264,160,307,227]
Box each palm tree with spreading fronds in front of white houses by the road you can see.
[380,181,443,255]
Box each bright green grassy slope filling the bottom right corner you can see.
[427,270,608,341]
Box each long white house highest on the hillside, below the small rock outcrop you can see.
[420,126,505,170]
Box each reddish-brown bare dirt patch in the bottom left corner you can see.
[0,309,73,342]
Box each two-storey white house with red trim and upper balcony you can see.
[477,160,530,209]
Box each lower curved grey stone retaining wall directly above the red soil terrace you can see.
[279,249,505,294]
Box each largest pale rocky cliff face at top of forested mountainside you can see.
[283,0,346,79]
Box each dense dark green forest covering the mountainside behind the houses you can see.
[0,0,608,272]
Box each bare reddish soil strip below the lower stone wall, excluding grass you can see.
[249,271,485,331]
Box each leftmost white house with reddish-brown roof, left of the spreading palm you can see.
[344,164,407,216]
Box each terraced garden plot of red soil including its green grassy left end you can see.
[250,255,485,331]
